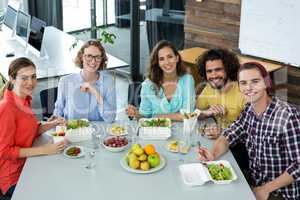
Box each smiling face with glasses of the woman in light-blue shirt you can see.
[82,45,102,72]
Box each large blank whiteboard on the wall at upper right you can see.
[239,0,300,67]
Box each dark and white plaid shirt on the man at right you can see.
[223,97,300,200]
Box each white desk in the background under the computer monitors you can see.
[0,27,129,79]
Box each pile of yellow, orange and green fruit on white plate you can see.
[126,144,160,171]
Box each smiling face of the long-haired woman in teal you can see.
[158,47,178,75]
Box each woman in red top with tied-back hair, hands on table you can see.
[0,58,65,199]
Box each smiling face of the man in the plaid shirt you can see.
[239,69,268,104]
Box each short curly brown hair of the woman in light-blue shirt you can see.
[74,40,107,71]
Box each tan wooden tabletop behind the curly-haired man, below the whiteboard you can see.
[180,47,283,72]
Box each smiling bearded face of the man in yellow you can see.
[205,59,227,90]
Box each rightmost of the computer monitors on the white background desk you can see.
[28,16,46,51]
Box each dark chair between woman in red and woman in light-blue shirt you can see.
[40,87,57,120]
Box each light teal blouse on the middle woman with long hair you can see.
[139,74,195,117]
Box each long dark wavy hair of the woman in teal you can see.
[148,40,186,94]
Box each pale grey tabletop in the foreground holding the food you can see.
[12,122,255,200]
